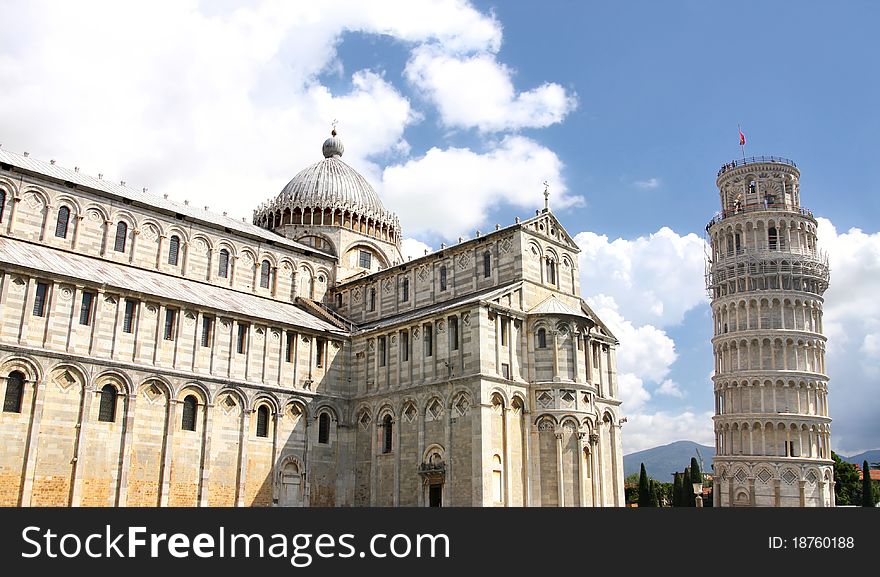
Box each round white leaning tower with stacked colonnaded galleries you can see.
[706,156,834,507]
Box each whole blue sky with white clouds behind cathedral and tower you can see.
[0,0,880,454]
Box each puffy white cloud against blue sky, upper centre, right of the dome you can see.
[406,45,577,132]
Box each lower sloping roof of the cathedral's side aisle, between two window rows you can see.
[0,237,346,334]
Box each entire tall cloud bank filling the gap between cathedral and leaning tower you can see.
[575,227,714,453]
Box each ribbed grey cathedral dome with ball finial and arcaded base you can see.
[254,130,400,244]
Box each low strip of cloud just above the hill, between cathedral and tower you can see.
[621,411,715,454]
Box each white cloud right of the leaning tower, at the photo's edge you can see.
[818,218,880,455]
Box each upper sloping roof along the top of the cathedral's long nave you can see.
[0,148,335,258]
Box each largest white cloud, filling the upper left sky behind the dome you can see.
[0,0,501,216]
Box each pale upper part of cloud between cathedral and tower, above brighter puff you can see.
[575,227,708,327]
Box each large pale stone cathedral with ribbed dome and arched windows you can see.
[0,131,624,507]
